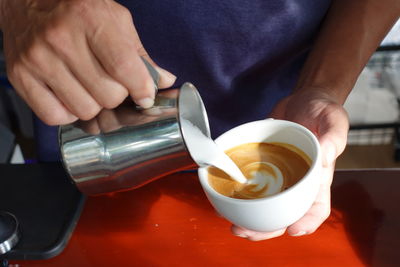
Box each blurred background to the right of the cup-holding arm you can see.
[336,20,400,169]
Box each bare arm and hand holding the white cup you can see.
[232,0,400,240]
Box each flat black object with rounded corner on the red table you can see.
[0,163,85,260]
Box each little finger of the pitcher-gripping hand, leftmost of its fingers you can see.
[9,67,77,125]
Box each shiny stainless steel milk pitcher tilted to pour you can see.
[59,83,210,195]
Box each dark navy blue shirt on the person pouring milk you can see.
[35,0,330,160]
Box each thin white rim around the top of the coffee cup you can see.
[197,118,321,204]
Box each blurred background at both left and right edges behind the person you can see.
[0,21,400,169]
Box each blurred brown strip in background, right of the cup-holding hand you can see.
[336,144,400,169]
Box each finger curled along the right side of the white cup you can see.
[287,167,333,236]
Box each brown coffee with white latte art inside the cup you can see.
[208,143,311,199]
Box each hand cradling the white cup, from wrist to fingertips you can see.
[232,90,349,241]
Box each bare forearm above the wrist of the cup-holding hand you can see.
[296,0,400,104]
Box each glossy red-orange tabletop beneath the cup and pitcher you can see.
[11,170,400,267]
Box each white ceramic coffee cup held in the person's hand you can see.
[198,119,322,232]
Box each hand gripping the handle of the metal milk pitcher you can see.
[0,0,175,125]
